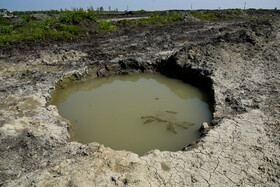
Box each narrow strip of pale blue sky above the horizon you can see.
[0,0,280,11]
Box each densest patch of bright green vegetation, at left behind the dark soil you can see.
[0,10,97,46]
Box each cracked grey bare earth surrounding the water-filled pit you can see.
[0,19,280,186]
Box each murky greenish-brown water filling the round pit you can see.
[53,74,212,155]
